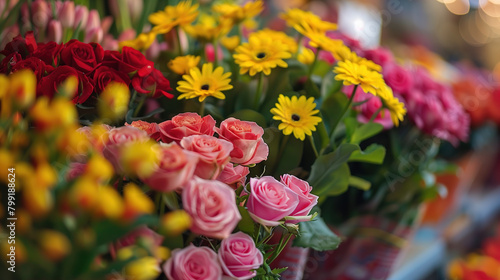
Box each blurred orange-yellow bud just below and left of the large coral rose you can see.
[122,183,155,221]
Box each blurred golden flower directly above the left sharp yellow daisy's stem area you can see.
[184,14,232,42]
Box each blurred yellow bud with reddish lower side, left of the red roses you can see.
[9,69,36,108]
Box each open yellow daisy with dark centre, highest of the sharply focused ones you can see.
[233,36,292,76]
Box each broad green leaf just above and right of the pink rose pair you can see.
[307,144,359,195]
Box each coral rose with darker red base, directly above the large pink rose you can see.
[141,143,198,192]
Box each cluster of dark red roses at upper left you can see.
[0,32,173,104]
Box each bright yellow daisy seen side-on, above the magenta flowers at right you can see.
[333,60,386,96]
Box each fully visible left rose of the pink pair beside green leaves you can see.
[247,176,299,226]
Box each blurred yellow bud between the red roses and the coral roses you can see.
[97,82,130,120]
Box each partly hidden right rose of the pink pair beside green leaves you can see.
[281,174,318,223]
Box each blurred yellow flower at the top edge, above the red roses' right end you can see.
[149,0,198,34]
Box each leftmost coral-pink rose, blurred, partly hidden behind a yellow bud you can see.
[102,126,149,173]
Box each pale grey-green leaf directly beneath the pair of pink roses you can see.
[293,217,341,251]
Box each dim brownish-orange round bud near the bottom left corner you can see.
[39,230,71,261]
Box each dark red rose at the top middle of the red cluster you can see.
[61,39,104,74]
